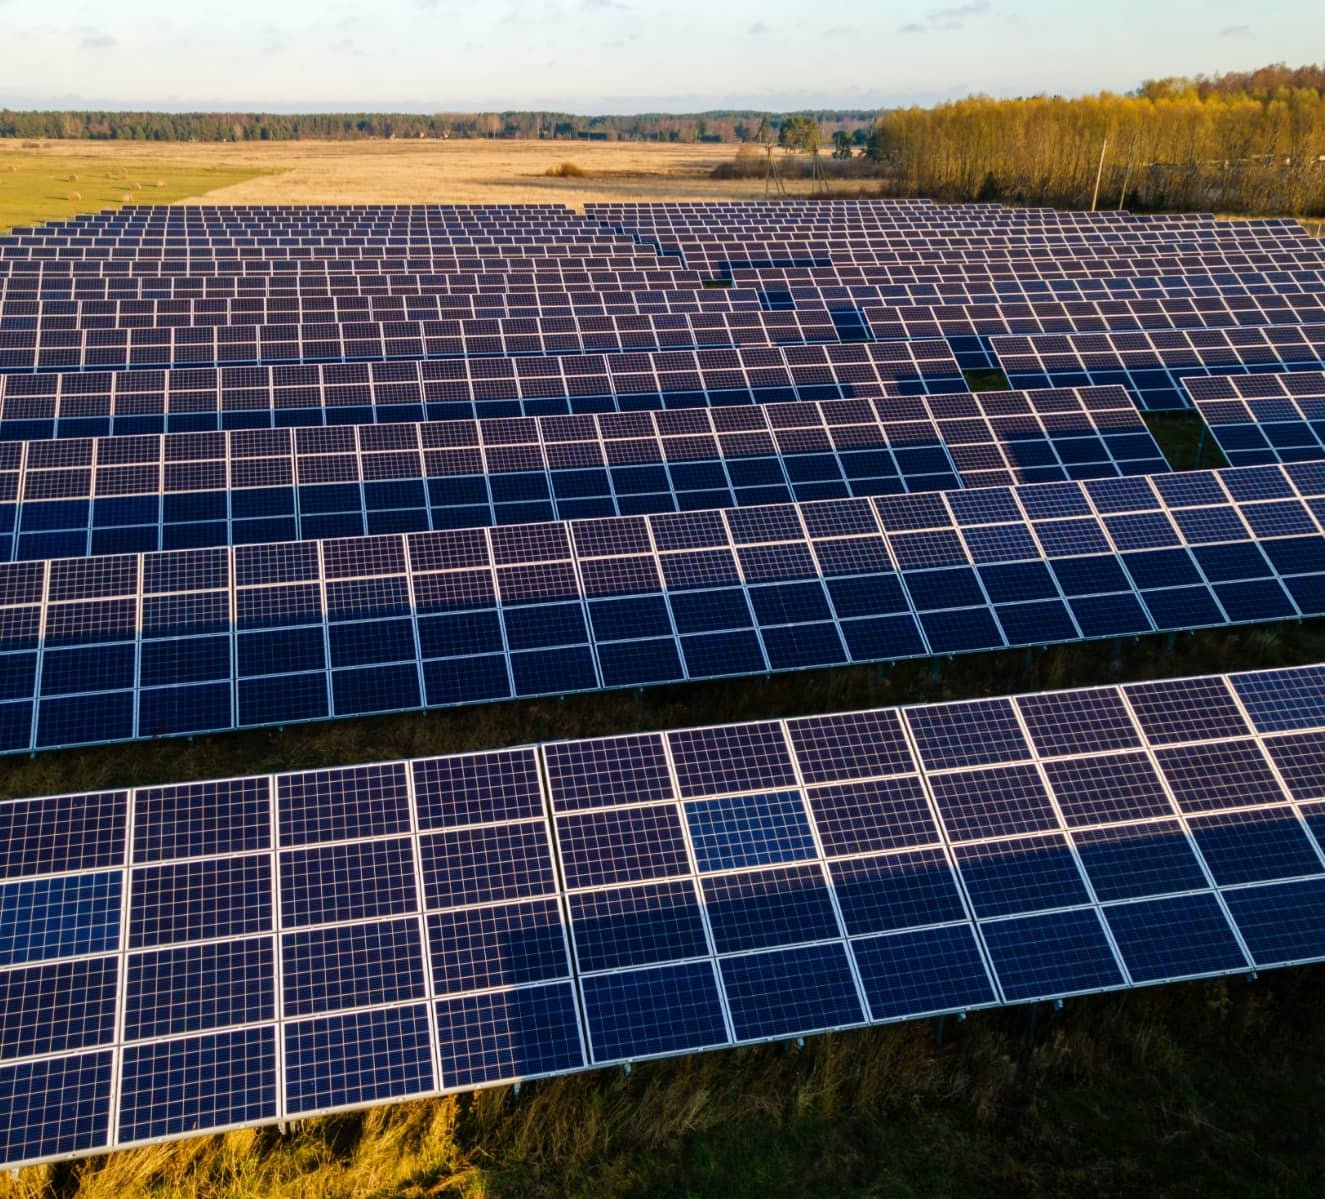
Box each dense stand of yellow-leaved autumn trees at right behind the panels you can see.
[867,81,1325,215]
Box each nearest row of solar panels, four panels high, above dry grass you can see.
[0,668,1325,1165]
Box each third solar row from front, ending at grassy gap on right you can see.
[0,388,1169,560]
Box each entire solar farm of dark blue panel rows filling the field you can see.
[0,201,1325,1165]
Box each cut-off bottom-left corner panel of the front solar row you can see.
[0,1049,111,1162]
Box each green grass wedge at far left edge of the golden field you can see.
[0,150,272,231]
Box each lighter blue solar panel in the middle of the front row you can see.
[685,791,815,872]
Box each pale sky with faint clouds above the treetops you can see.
[0,0,1325,113]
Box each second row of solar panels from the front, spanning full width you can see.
[0,464,1325,751]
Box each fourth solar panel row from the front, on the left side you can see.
[0,342,966,441]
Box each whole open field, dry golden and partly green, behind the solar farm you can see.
[0,140,837,228]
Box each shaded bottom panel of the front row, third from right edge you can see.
[981,908,1124,1003]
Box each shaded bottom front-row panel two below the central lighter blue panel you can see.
[719,943,865,1041]
